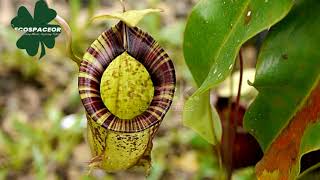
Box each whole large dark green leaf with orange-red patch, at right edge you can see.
[244,0,320,179]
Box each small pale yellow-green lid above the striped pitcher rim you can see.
[92,9,162,27]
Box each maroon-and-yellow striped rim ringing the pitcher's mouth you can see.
[78,21,176,132]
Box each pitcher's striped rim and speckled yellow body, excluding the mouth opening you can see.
[78,21,176,172]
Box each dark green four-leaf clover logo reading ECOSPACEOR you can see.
[11,0,61,59]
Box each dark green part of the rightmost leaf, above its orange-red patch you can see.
[244,0,320,151]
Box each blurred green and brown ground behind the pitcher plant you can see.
[0,0,253,180]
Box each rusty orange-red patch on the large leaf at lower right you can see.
[256,81,320,180]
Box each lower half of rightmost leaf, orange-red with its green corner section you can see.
[256,83,320,179]
